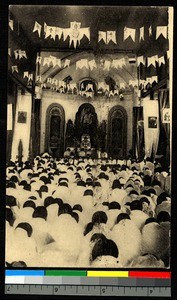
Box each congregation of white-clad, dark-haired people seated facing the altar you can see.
[6,153,171,268]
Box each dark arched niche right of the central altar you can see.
[107,105,127,158]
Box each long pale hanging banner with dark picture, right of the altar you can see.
[143,98,159,157]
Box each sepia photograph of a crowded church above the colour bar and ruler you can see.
[5,5,173,269]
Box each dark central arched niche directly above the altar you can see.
[75,103,98,148]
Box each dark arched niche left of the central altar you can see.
[45,103,65,157]
